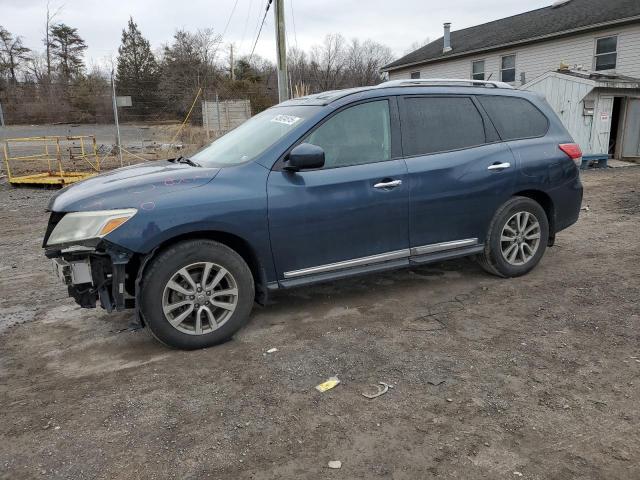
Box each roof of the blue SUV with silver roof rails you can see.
[278,78,514,107]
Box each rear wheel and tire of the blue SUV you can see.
[478,197,549,278]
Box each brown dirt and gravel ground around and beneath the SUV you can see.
[0,167,640,480]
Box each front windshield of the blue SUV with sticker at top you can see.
[191,105,321,167]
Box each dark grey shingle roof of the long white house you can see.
[383,0,640,70]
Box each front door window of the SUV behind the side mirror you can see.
[304,100,391,168]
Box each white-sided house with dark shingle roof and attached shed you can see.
[383,0,640,159]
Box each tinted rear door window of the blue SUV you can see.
[402,97,487,157]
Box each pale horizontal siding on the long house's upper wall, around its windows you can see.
[389,24,640,86]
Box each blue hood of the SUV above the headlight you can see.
[48,160,220,212]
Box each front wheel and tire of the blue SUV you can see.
[140,240,255,350]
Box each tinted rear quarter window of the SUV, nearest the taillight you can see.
[477,95,549,141]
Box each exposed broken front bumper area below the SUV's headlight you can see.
[45,241,136,312]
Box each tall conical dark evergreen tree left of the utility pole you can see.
[116,17,158,114]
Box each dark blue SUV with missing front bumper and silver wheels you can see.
[43,80,582,349]
